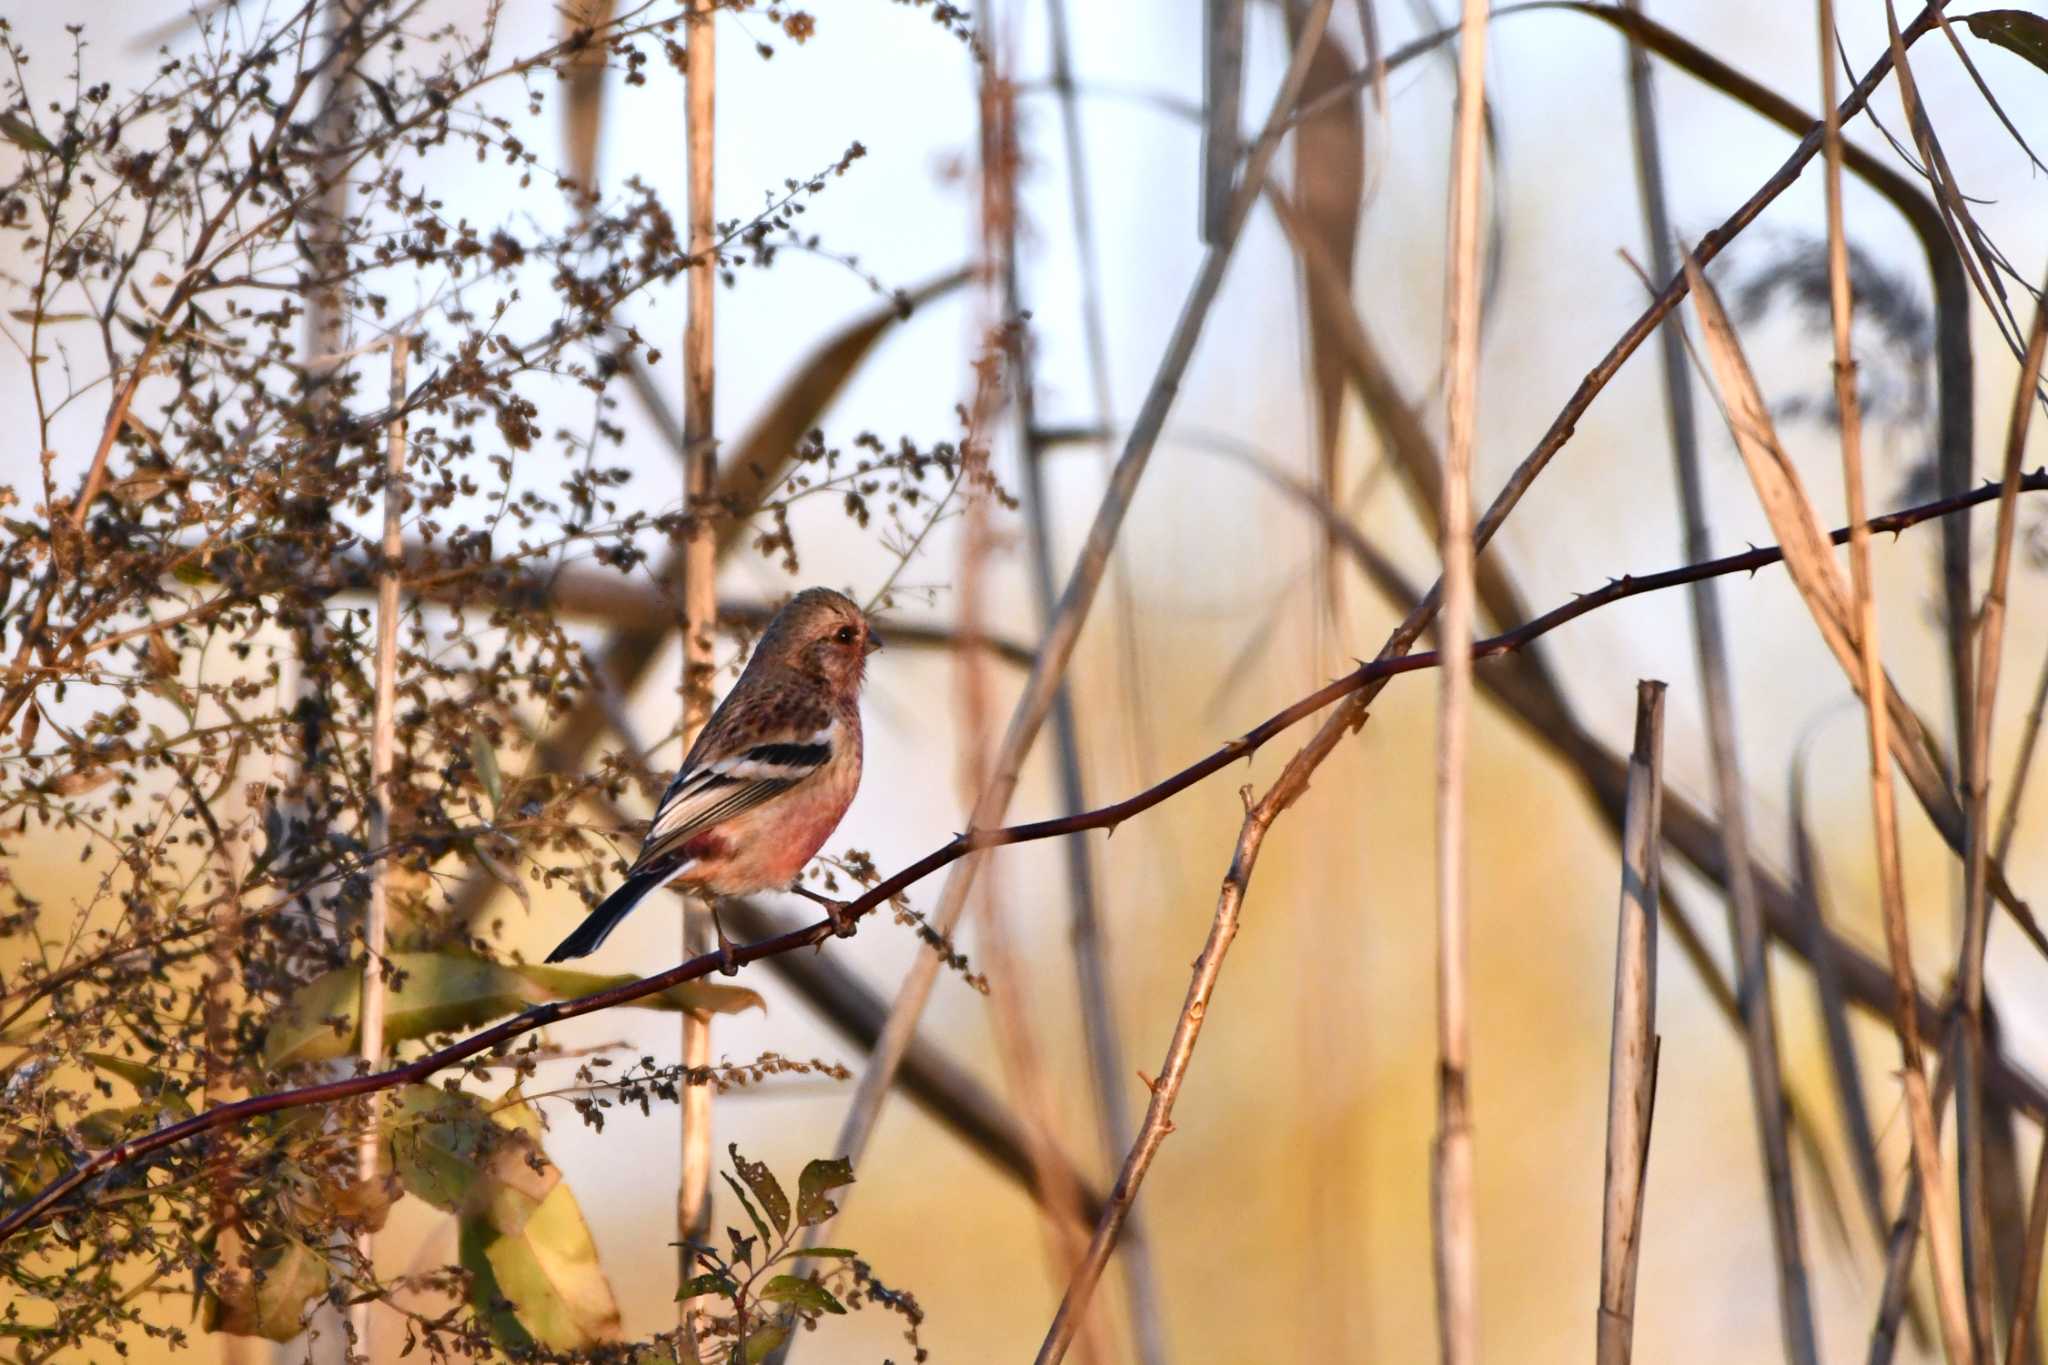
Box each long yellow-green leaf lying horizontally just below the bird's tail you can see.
[264,952,766,1066]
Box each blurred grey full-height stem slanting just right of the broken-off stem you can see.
[1628,0,1835,1365]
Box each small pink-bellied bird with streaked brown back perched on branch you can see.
[547,587,883,962]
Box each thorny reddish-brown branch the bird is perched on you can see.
[0,469,2048,1242]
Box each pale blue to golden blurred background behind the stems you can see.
[0,0,2048,1363]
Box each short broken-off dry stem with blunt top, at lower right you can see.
[1595,681,1665,1365]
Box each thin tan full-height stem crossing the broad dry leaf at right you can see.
[1819,13,1966,1361]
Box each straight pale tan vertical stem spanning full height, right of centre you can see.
[1430,0,1487,1365]
